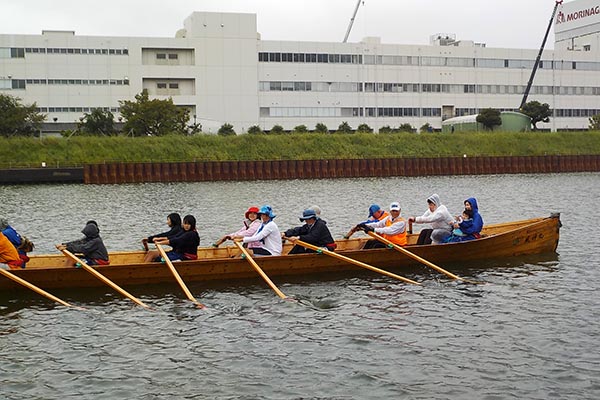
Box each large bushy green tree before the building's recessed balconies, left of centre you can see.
[119,89,190,136]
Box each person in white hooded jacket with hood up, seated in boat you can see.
[408,193,454,244]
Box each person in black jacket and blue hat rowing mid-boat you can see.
[283,209,336,254]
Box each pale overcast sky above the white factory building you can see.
[0,0,555,49]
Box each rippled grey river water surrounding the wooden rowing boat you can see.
[0,174,600,400]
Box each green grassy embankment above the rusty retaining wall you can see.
[0,132,600,168]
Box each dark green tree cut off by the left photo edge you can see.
[0,94,46,137]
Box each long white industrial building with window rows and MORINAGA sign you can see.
[0,0,600,133]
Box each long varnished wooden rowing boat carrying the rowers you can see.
[0,214,561,289]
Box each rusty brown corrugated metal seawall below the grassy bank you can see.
[84,155,600,184]
